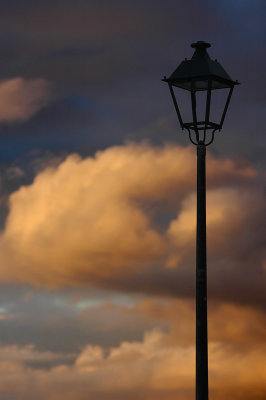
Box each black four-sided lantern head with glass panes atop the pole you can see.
[163,41,238,145]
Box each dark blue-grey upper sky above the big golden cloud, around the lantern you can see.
[0,0,266,166]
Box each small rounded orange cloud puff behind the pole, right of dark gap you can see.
[167,187,262,268]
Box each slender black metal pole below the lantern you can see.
[196,142,208,400]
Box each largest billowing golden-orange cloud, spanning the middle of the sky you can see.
[0,144,264,306]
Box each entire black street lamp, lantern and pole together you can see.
[163,41,238,400]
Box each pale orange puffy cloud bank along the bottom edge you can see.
[0,330,265,400]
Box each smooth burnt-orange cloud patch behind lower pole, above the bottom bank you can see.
[133,298,266,351]
